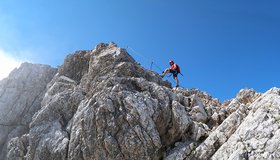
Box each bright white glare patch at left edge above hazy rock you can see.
[0,49,22,80]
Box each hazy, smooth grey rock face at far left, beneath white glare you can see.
[0,63,56,159]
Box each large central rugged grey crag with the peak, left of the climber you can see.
[8,44,228,159]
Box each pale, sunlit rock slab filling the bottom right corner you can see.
[212,88,280,160]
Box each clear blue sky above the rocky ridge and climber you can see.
[0,0,280,100]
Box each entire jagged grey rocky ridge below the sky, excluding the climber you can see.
[0,43,280,160]
